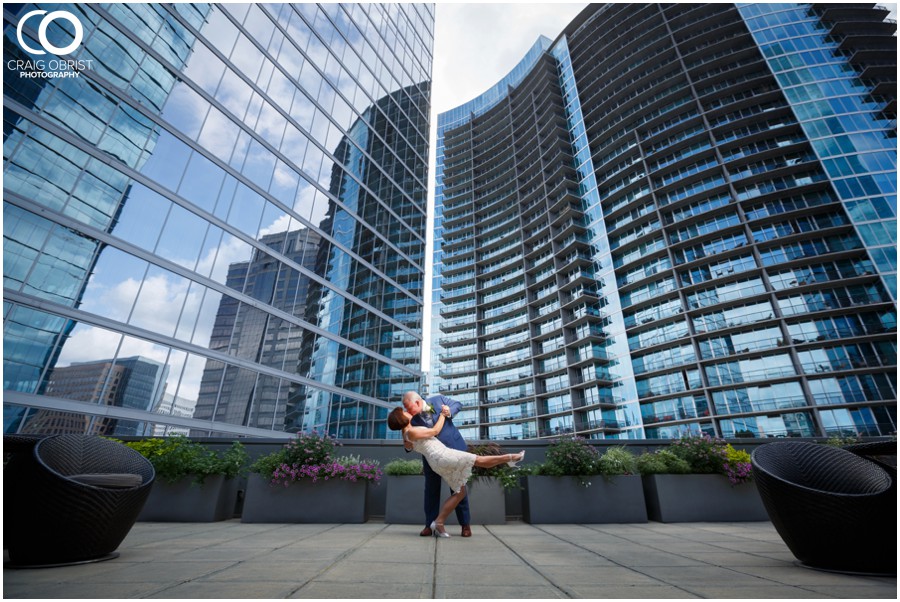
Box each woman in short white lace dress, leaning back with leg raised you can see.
[388,408,525,537]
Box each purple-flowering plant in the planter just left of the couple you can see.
[250,431,382,487]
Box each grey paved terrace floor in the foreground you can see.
[3,520,897,599]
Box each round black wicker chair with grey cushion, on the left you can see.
[3,435,155,568]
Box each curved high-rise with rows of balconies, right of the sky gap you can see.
[432,3,897,439]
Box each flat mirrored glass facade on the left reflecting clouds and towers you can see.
[3,4,434,438]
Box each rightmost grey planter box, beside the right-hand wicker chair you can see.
[643,474,769,523]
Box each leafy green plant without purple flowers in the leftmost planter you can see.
[125,435,248,484]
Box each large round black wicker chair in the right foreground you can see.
[751,441,897,575]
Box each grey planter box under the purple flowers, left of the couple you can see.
[241,474,368,523]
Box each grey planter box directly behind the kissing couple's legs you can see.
[384,475,506,525]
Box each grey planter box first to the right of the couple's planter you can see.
[522,475,647,524]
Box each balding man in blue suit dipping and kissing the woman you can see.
[403,391,472,537]
